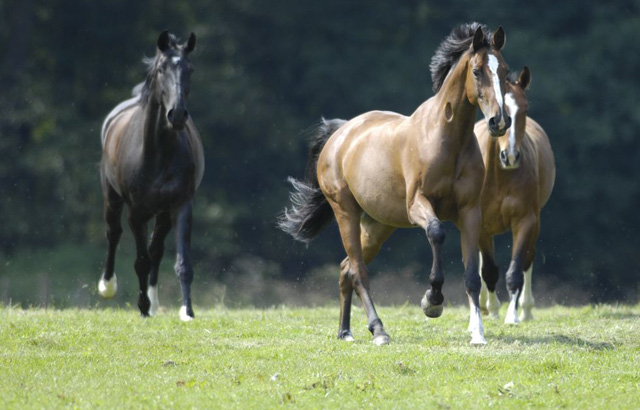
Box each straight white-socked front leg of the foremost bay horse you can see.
[458,206,487,344]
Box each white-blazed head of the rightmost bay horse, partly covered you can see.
[498,66,531,169]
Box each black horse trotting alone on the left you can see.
[98,31,204,321]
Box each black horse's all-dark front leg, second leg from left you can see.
[128,210,151,317]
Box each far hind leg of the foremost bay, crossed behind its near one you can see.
[338,213,395,341]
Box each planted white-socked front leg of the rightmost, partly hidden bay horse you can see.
[504,214,540,324]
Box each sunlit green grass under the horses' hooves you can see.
[0,305,640,409]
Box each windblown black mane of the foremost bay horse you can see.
[429,22,492,93]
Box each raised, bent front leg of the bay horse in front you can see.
[409,195,446,318]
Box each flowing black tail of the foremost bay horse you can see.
[278,118,346,243]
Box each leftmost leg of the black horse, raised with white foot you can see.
[98,183,124,299]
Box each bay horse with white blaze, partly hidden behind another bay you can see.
[475,67,556,324]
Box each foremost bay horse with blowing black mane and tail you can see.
[279,23,510,345]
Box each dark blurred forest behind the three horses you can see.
[0,0,640,306]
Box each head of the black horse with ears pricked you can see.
[154,30,196,131]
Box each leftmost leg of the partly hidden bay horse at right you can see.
[479,235,500,319]
